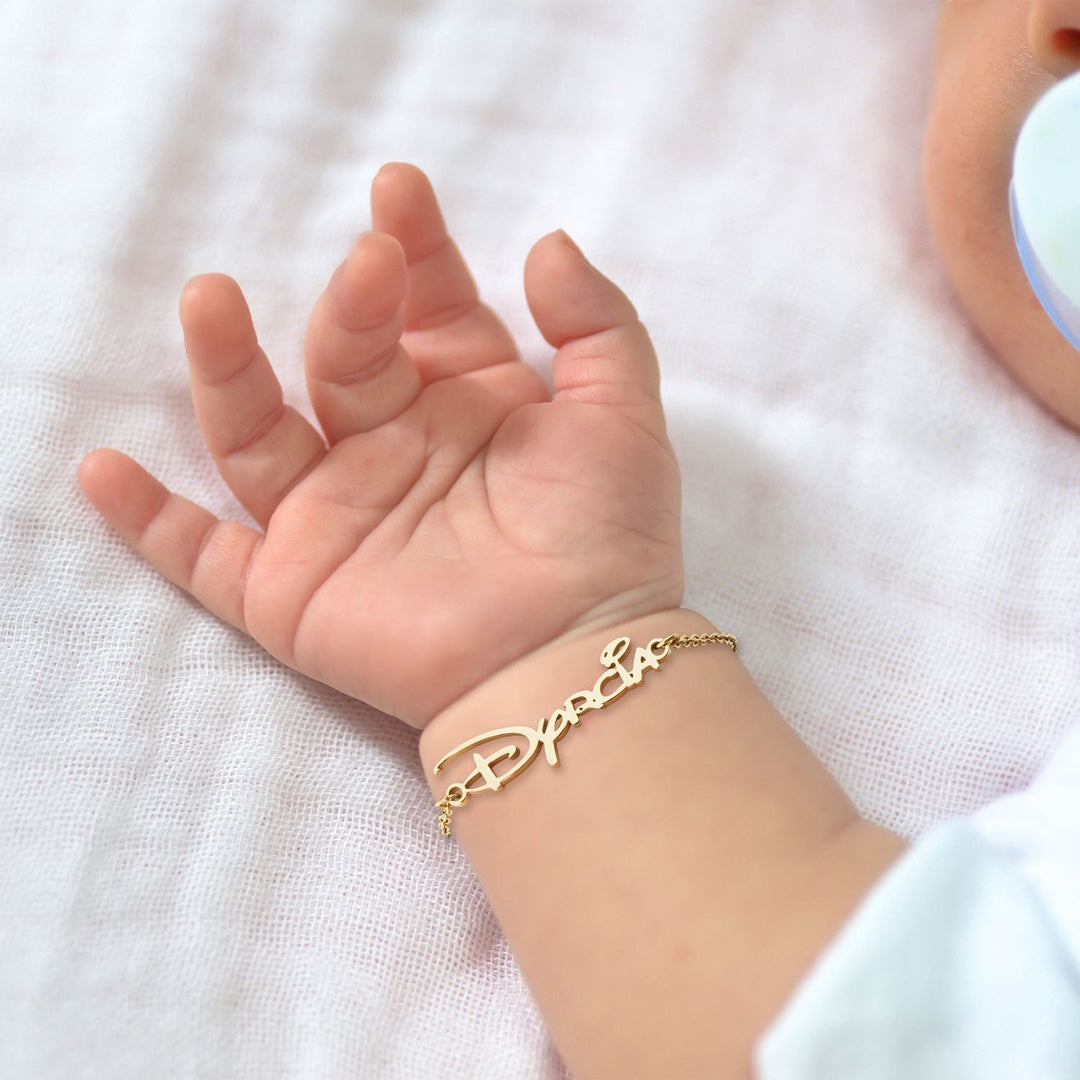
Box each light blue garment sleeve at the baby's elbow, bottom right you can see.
[755,821,1080,1080]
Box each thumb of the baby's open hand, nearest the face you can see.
[525,230,664,436]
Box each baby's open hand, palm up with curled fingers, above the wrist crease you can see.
[79,164,683,728]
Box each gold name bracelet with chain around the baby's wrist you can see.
[433,634,739,836]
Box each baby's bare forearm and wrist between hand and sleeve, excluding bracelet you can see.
[420,610,903,1078]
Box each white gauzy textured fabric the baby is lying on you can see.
[6,0,1080,1080]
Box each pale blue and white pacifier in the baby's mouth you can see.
[1009,75,1080,349]
